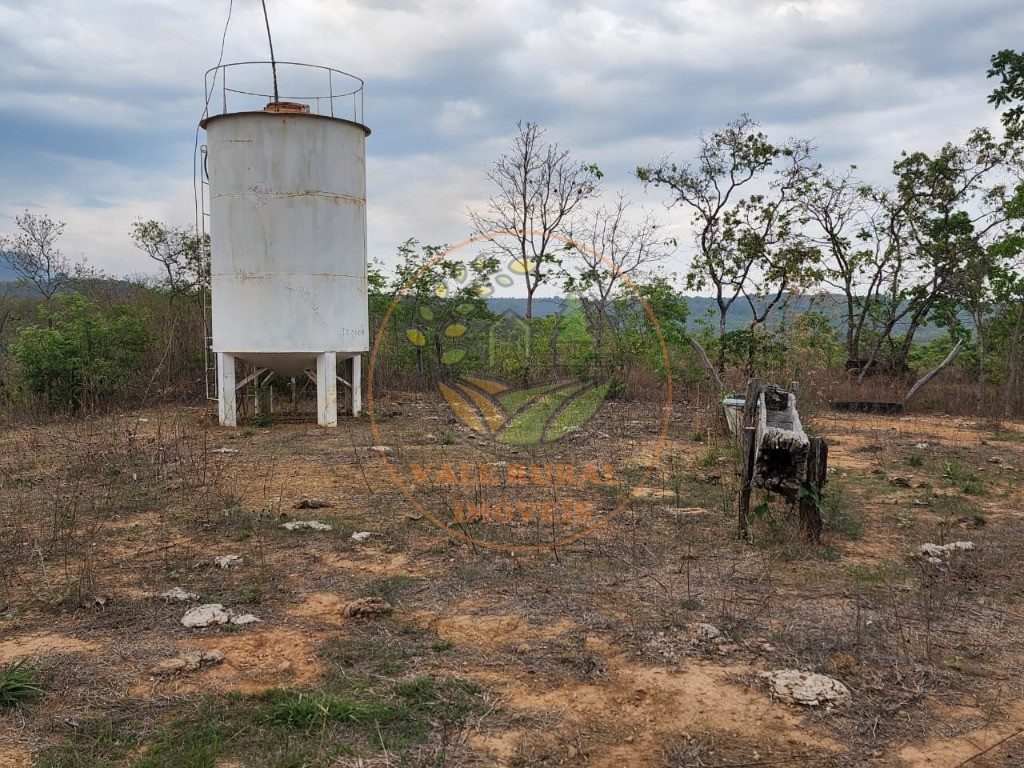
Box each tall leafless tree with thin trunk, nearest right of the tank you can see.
[469,121,601,379]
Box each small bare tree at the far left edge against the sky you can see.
[0,211,75,303]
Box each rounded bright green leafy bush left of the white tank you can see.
[11,294,151,411]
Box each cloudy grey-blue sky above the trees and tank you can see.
[0,0,1024,274]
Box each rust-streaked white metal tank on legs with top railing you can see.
[201,62,370,425]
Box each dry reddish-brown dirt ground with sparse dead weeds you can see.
[0,395,1024,768]
